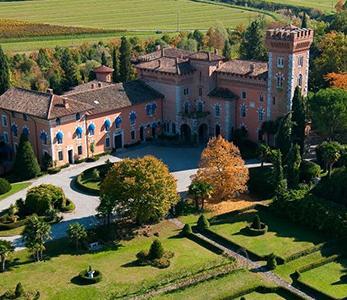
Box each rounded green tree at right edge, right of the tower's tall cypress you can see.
[309,88,347,139]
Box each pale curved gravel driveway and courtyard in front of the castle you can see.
[0,145,259,250]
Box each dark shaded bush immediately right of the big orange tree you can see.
[248,166,275,199]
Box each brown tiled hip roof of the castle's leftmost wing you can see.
[0,88,93,120]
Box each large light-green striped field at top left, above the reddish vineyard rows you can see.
[0,0,272,31]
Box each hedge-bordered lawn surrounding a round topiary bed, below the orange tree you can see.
[210,210,326,259]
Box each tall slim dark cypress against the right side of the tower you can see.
[292,87,306,154]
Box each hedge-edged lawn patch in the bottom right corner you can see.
[299,259,347,299]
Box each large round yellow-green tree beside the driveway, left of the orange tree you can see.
[99,156,179,224]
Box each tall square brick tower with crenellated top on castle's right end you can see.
[266,25,313,120]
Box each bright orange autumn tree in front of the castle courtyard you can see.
[195,136,249,203]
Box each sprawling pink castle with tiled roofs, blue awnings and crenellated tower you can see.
[0,25,313,165]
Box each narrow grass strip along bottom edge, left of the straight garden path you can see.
[153,270,274,300]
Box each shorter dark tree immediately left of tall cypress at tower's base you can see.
[276,113,292,160]
